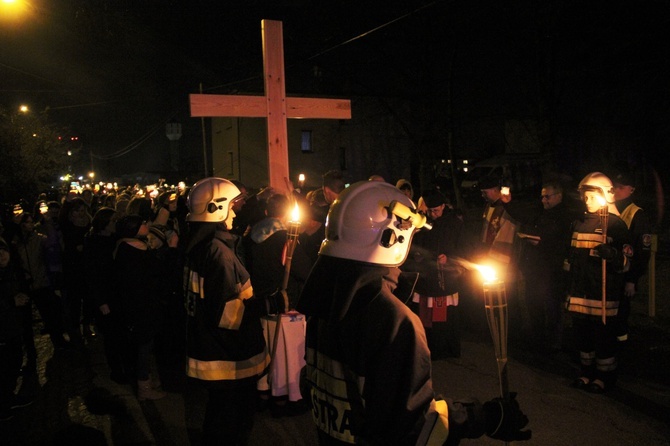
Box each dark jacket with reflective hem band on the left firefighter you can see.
[185,230,269,381]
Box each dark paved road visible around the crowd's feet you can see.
[0,314,670,446]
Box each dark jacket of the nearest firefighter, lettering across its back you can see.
[298,256,483,445]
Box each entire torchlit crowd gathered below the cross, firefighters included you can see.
[0,166,651,444]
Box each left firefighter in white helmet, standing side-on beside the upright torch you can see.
[185,177,269,445]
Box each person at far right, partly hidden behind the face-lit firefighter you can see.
[613,172,652,341]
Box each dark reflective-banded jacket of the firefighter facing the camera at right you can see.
[568,213,631,317]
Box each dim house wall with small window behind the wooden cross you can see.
[211,100,416,188]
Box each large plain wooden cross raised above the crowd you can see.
[190,20,351,191]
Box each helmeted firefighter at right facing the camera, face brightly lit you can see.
[565,172,632,393]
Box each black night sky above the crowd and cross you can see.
[0,0,670,195]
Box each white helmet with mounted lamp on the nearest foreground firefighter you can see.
[319,181,428,266]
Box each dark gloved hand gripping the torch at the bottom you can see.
[484,392,532,441]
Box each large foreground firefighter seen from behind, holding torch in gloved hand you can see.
[298,181,531,445]
